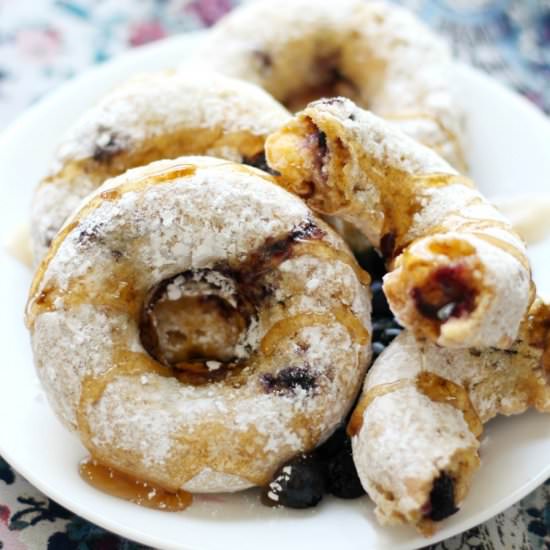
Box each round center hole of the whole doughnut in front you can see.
[140,275,247,372]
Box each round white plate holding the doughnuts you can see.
[0,31,550,550]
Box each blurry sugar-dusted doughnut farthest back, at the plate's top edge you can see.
[194,0,465,170]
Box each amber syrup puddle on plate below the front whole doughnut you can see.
[79,458,193,512]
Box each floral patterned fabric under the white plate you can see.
[0,0,550,550]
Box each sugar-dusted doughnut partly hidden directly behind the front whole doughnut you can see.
[31,71,289,260]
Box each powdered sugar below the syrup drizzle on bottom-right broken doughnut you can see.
[352,387,479,525]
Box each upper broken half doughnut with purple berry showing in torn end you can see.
[266,98,534,348]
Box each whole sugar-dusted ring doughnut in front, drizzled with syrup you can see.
[27,157,370,492]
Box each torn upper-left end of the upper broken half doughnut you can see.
[266,117,350,215]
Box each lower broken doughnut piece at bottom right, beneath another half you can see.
[348,302,550,534]
